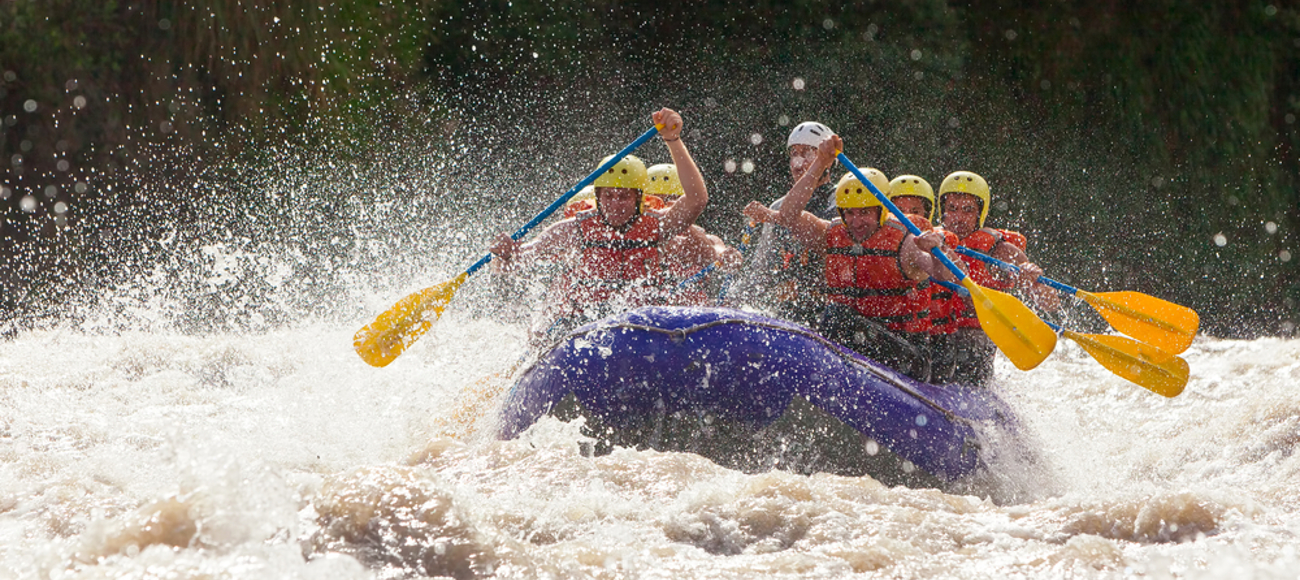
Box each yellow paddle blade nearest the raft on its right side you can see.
[962,278,1057,371]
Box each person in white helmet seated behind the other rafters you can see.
[732,121,836,325]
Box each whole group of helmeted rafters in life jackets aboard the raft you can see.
[491,109,1058,386]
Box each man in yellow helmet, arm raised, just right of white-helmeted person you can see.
[779,137,956,380]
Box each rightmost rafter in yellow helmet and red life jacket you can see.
[936,170,1060,385]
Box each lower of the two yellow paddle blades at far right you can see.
[1065,330,1188,397]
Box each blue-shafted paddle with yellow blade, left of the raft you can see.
[352,126,659,367]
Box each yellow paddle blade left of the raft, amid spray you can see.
[352,273,469,367]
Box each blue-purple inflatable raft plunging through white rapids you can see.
[498,307,1017,485]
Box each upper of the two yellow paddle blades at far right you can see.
[1079,291,1201,355]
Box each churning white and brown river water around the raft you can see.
[0,258,1300,579]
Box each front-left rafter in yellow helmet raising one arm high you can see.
[490,109,709,338]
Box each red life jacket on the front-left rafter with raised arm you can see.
[568,211,662,306]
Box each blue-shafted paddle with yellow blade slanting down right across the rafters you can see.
[836,152,1057,371]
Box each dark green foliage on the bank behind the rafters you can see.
[0,0,1300,336]
